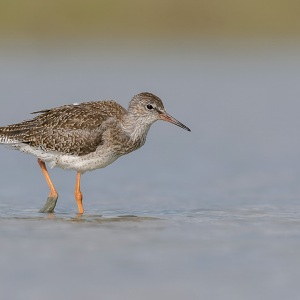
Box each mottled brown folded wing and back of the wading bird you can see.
[0,101,126,155]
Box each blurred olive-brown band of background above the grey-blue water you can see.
[0,0,300,41]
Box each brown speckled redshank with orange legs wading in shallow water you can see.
[0,93,191,214]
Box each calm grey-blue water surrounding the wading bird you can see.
[0,39,300,300]
